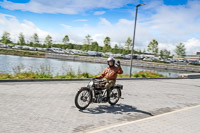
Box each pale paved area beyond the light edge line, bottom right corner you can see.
[89,105,200,133]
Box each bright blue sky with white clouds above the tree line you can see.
[0,0,200,54]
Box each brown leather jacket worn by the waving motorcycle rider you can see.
[97,66,123,80]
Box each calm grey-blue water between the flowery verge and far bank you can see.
[0,55,188,77]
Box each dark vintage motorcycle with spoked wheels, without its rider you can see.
[75,79,123,110]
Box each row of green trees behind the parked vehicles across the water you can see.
[0,32,186,58]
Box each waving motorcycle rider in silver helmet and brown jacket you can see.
[96,57,123,98]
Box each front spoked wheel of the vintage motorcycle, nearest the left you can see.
[75,89,92,110]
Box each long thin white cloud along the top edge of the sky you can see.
[0,0,132,14]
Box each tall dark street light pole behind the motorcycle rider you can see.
[130,3,145,78]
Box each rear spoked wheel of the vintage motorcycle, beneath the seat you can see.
[108,88,121,105]
